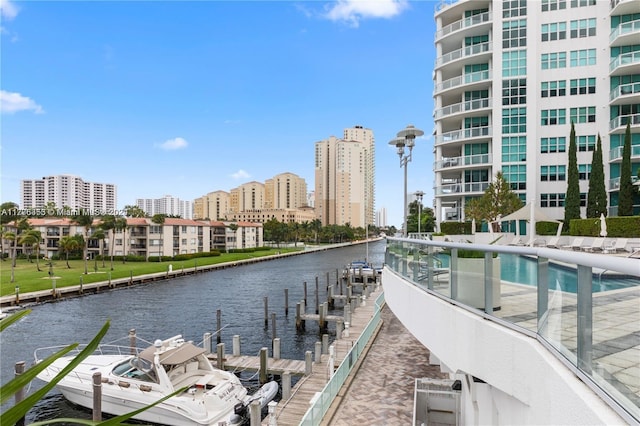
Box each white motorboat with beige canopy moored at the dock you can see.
[35,335,278,425]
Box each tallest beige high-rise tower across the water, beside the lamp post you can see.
[315,126,375,227]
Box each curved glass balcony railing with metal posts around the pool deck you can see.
[385,238,640,424]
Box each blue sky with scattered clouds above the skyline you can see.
[0,0,435,227]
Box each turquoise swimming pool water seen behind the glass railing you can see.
[437,253,640,293]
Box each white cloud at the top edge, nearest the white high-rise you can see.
[325,0,409,27]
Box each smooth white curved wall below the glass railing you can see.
[382,267,626,425]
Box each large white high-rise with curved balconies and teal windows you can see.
[433,0,640,230]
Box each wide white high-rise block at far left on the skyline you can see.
[20,175,117,215]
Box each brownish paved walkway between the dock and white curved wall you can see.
[322,306,446,426]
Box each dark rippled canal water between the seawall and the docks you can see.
[0,240,386,422]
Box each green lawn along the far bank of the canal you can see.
[0,248,300,296]
